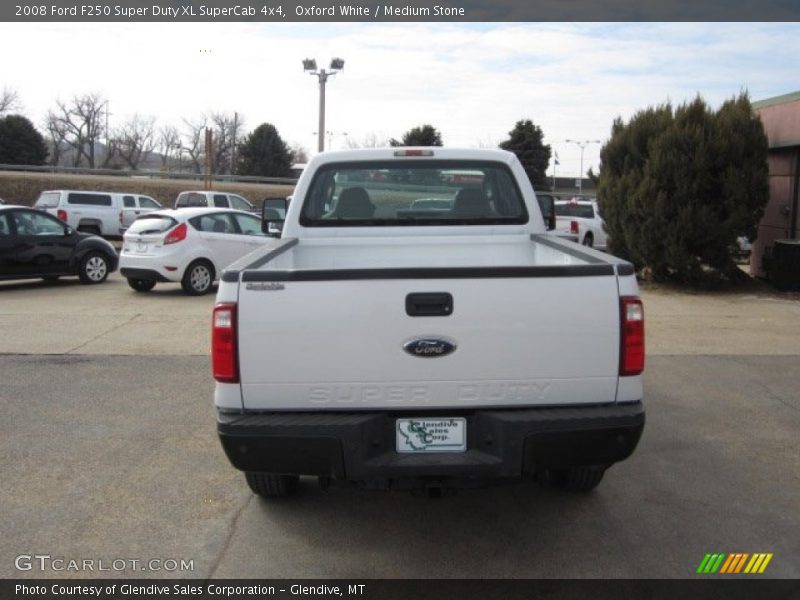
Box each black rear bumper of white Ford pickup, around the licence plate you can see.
[217,402,645,482]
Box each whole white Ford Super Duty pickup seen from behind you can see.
[212,148,644,497]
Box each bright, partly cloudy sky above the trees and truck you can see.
[0,23,800,175]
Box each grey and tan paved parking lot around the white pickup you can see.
[0,275,800,578]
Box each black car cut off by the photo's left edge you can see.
[0,204,119,283]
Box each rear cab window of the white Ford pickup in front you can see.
[300,160,528,227]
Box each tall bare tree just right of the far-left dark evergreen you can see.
[48,94,107,169]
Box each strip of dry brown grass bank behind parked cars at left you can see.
[0,171,294,207]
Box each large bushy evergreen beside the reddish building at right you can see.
[598,94,769,281]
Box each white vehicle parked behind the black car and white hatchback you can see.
[33,190,162,237]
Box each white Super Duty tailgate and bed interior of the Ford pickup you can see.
[238,238,619,411]
